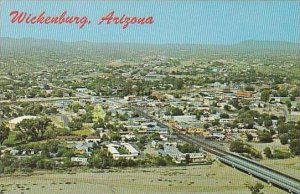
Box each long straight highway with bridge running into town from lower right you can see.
[131,106,300,194]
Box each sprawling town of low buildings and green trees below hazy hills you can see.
[0,40,300,192]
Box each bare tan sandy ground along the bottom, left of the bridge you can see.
[0,162,284,194]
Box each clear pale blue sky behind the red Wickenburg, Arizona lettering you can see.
[0,0,300,44]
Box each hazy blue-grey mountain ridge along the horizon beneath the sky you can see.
[0,38,300,55]
